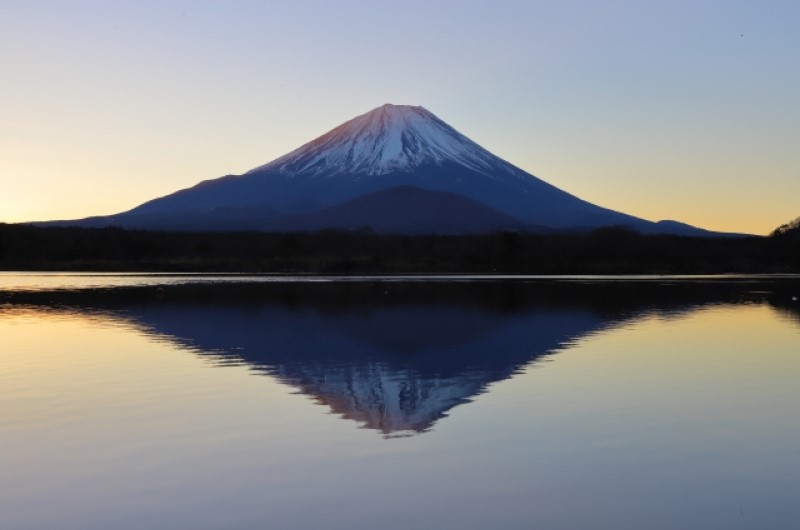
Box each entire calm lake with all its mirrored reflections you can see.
[0,273,800,530]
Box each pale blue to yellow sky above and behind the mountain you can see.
[0,0,800,234]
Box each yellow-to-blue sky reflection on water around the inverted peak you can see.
[0,304,800,529]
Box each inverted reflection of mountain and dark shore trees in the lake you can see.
[6,282,798,437]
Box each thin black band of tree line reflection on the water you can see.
[0,276,776,316]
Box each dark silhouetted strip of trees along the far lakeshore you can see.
[0,224,800,274]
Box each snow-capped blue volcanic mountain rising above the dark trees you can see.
[54,104,712,235]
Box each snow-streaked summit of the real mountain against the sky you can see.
[250,103,504,175]
